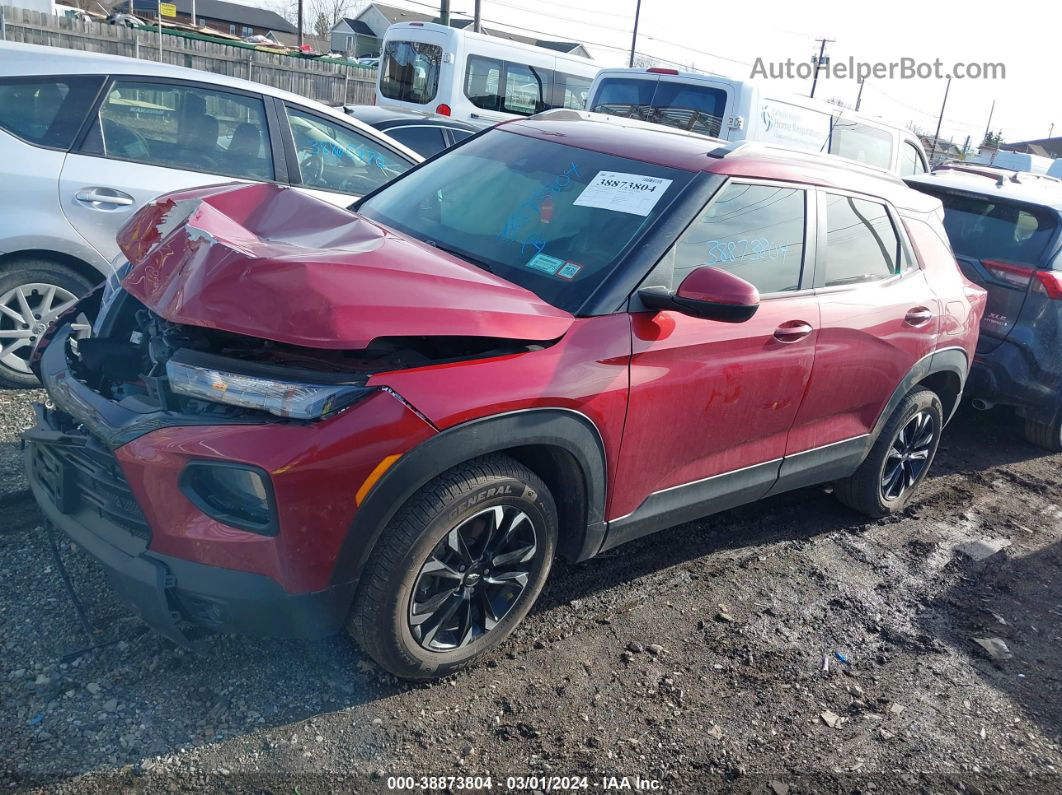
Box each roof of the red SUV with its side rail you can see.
[499,110,939,212]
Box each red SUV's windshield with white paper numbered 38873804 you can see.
[357,129,692,312]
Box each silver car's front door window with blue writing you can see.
[287,106,412,196]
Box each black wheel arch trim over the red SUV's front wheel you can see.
[332,408,607,583]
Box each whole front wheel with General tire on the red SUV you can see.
[347,455,558,679]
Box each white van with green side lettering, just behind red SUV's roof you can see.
[586,68,928,176]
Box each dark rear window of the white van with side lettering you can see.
[590,77,726,138]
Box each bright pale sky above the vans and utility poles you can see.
[284,0,1062,146]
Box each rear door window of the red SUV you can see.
[824,193,901,287]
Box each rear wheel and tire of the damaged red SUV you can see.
[834,388,944,519]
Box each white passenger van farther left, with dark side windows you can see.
[376,22,598,127]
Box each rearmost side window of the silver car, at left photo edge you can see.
[0,75,103,149]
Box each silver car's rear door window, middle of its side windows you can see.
[84,81,273,179]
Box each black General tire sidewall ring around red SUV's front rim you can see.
[378,477,556,676]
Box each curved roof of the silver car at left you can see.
[0,41,424,162]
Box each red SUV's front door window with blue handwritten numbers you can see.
[672,183,805,293]
